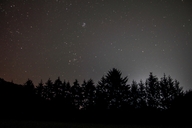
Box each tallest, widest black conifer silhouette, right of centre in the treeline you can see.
[97,68,128,110]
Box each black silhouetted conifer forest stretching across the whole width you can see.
[0,68,192,123]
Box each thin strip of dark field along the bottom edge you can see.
[0,120,190,128]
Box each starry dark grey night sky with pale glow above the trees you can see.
[0,0,192,89]
